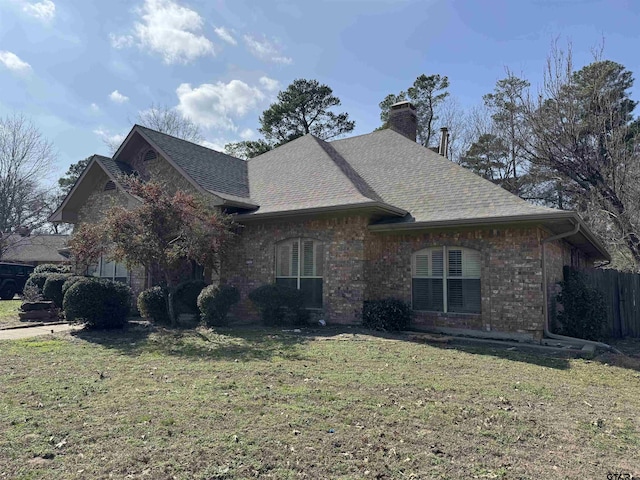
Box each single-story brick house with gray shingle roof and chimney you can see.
[51,102,610,338]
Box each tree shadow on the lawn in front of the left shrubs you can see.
[72,322,309,361]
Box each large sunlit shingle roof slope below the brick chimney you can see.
[331,129,558,222]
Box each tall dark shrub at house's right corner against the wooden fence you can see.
[556,267,607,340]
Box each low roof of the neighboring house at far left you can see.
[2,235,69,263]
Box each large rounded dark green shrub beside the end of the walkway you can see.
[62,278,131,329]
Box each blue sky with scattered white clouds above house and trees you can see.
[0,0,640,185]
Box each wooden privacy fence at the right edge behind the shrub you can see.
[583,269,640,338]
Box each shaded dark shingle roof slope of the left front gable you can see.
[136,125,249,200]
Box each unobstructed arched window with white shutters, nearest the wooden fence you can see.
[411,247,481,313]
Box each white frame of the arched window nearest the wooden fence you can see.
[411,245,482,315]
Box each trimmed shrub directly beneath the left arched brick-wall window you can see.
[249,284,309,326]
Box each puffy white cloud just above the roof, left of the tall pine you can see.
[176,80,265,130]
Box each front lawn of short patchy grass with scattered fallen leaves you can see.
[0,327,640,479]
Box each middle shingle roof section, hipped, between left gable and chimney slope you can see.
[246,135,405,216]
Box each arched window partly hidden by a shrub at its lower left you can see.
[276,238,324,308]
